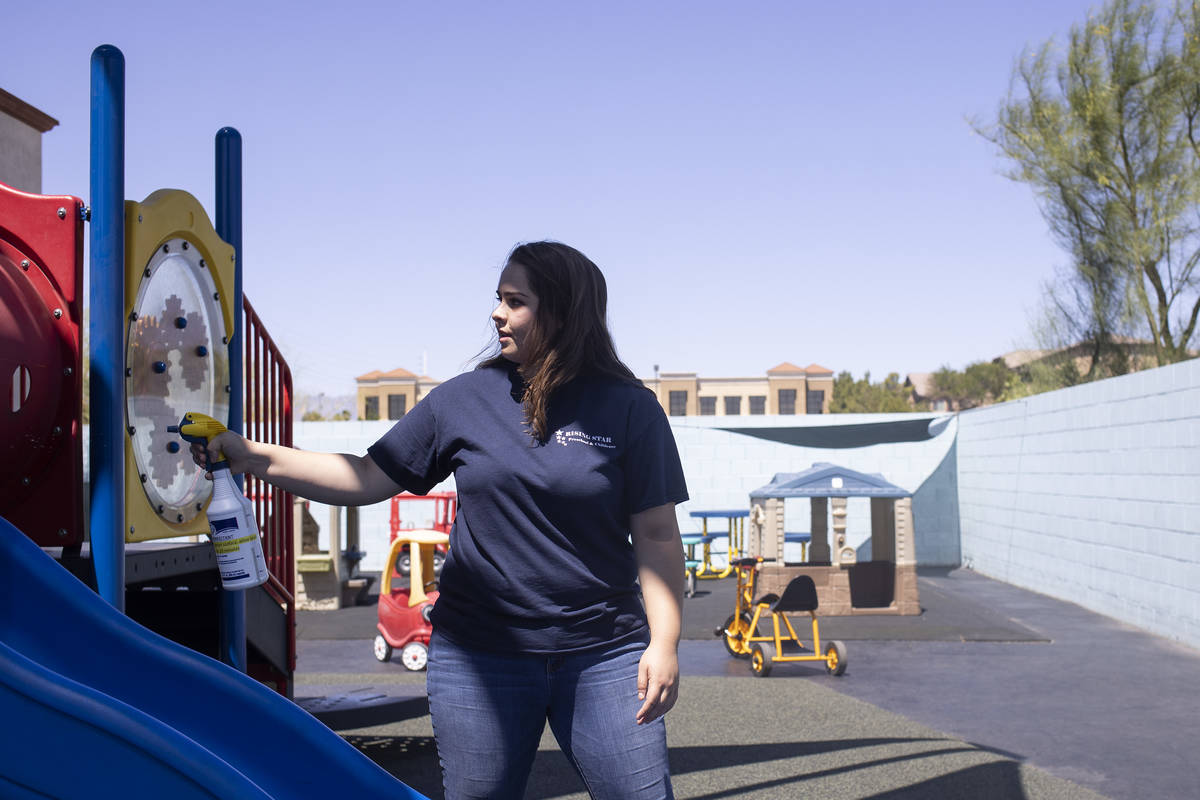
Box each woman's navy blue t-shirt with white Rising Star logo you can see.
[367,366,688,654]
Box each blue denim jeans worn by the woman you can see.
[427,630,674,800]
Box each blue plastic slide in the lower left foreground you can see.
[0,518,427,800]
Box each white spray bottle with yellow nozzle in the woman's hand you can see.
[167,411,268,590]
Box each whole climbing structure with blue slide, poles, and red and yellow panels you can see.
[0,46,421,799]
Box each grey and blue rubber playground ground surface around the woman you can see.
[295,570,1200,800]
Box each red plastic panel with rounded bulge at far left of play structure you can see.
[0,184,83,547]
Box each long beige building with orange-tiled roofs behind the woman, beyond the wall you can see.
[355,361,833,420]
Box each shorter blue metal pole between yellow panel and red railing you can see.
[216,127,246,672]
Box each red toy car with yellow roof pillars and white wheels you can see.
[374,530,450,672]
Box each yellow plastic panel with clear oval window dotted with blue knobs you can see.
[125,190,235,542]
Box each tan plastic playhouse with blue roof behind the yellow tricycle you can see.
[746,463,920,616]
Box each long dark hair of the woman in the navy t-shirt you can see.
[480,241,640,441]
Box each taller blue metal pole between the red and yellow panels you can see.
[88,44,125,612]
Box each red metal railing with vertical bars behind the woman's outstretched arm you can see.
[242,296,296,679]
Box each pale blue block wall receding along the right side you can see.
[958,361,1200,646]
